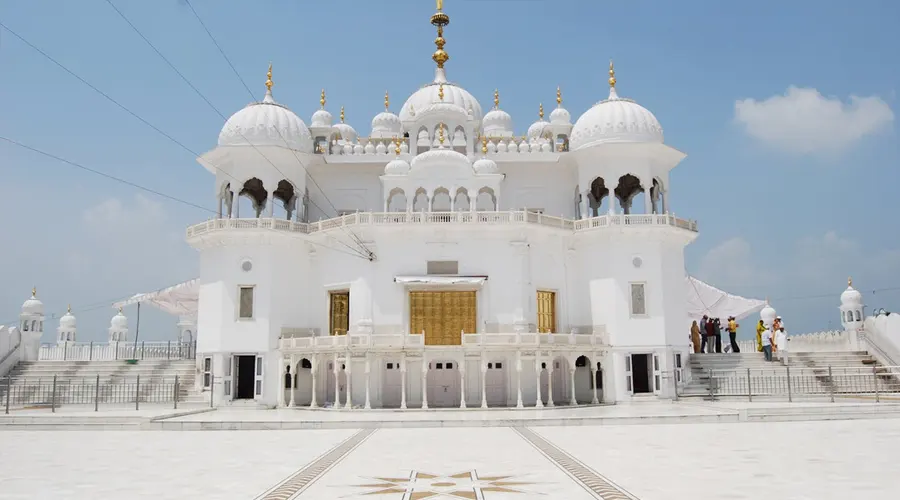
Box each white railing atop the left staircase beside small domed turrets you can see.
[38,341,197,361]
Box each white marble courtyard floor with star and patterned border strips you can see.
[0,419,900,500]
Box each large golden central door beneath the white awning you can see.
[409,292,477,345]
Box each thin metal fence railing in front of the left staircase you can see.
[0,375,202,414]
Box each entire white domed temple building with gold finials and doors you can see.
[187,1,761,408]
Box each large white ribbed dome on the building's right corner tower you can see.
[570,87,663,151]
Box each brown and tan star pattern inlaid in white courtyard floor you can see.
[342,470,543,500]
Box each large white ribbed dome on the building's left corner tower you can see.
[219,91,313,153]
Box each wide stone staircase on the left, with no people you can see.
[0,360,205,406]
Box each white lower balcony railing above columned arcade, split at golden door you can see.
[280,331,609,351]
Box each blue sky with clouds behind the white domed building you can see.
[0,0,900,341]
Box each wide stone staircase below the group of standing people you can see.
[679,351,900,398]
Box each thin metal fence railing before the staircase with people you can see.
[694,365,900,402]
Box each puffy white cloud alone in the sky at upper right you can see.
[734,86,894,154]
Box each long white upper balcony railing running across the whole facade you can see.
[187,210,697,238]
